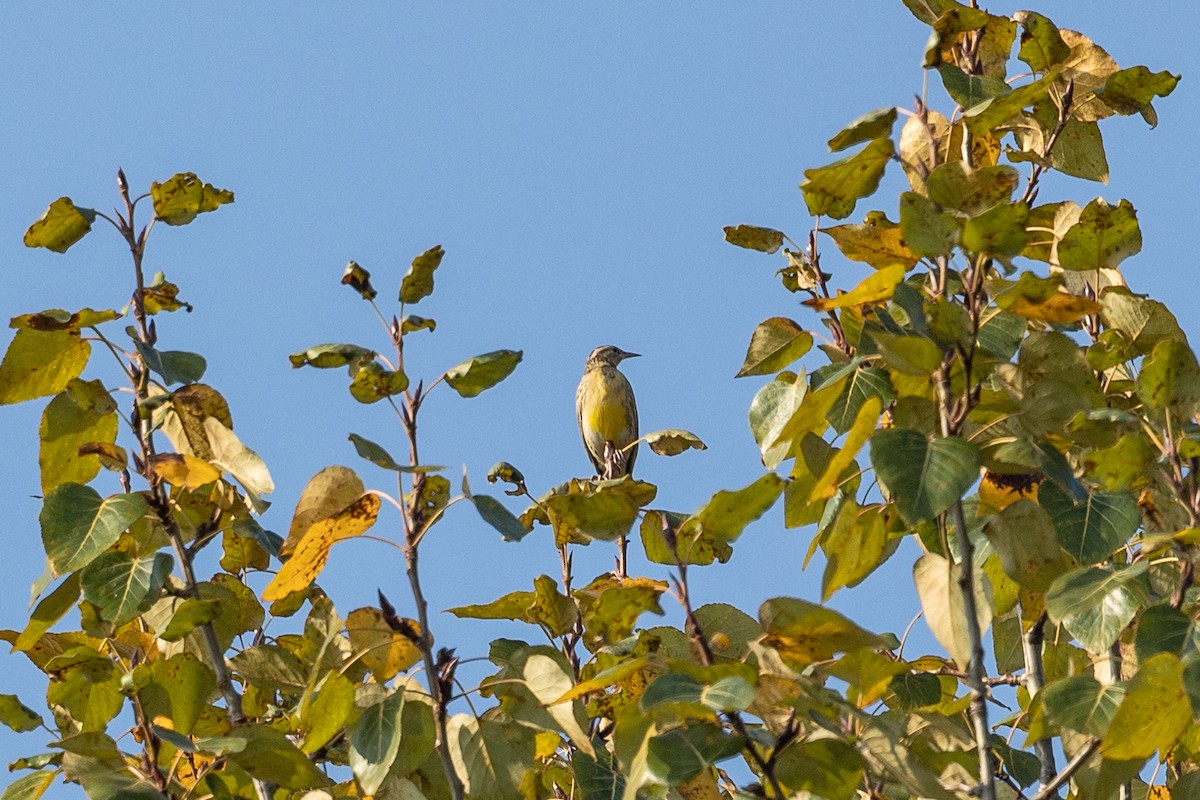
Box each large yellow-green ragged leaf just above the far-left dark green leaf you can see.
[37,379,116,494]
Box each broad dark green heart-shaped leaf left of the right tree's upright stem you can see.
[871,428,979,525]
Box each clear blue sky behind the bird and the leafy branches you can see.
[0,0,1200,782]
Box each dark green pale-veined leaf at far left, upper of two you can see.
[40,483,149,576]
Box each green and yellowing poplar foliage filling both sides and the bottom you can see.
[0,0,1200,800]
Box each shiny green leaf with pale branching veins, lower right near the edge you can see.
[1046,561,1148,654]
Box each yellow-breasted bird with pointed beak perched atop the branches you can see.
[575,344,638,480]
